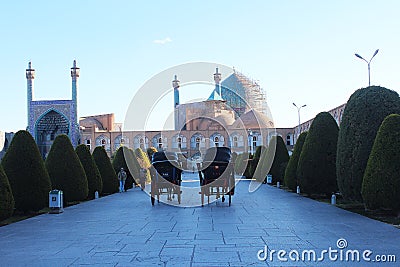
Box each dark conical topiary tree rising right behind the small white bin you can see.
[46,134,88,203]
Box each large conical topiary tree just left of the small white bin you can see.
[1,131,51,212]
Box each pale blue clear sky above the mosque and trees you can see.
[0,0,400,131]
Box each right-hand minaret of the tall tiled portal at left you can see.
[71,60,80,146]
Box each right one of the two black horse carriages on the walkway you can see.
[197,147,235,206]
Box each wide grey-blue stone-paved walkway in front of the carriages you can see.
[0,175,400,266]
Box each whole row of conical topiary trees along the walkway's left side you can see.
[0,131,138,220]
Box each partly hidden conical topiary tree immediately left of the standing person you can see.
[93,146,119,195]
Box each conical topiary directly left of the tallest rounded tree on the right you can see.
[296,112,339,195]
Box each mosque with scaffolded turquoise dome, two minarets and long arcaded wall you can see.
[80,68,293,159]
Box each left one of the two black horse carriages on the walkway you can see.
[151,151,182,205]
